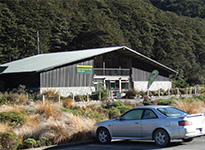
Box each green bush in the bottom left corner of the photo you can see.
[0,132,22,150]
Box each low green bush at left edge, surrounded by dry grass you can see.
[0,111,26,127]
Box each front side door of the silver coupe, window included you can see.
[112,109,143,137]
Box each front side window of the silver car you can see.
[121,109,143,120]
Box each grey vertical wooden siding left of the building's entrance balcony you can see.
[40,60,93,87]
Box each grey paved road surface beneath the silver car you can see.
[44,136,205,150]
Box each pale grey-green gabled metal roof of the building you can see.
[0,46,177,74]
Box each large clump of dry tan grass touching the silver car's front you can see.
[33,113,95,144]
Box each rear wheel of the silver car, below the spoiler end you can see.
[154,129,170,147]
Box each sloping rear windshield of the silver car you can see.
[157,107,189,117]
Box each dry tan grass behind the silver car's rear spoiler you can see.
[173,100,205,114]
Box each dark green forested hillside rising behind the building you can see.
[0,0,205,86]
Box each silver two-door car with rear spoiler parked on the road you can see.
[93,105,205,147]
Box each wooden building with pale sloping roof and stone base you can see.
[0,46,177,96]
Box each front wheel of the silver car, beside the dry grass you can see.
[97,128,111,144]
